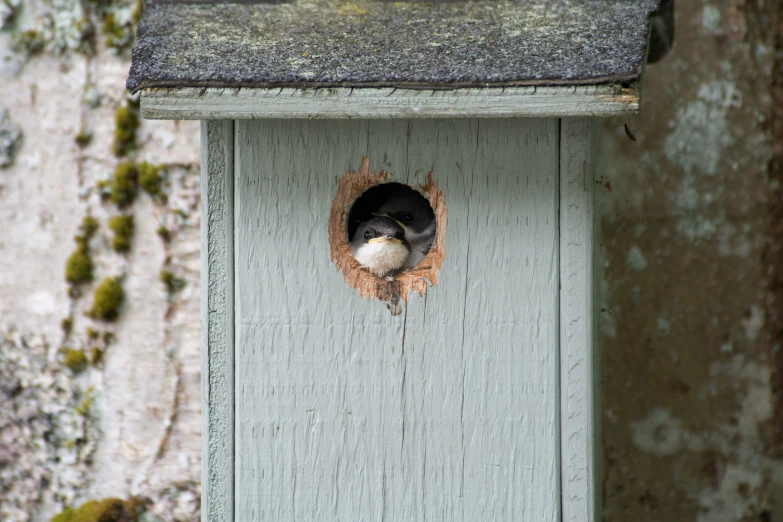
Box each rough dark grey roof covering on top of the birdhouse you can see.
[127,0,658,91]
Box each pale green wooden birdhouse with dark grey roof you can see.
[128,0,671,522]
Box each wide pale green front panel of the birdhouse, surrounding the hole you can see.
[236,119,560,522]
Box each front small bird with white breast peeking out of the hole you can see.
[350,216,411,278]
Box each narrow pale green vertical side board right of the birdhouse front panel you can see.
[560,118,601,522]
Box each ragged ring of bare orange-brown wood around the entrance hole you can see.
[329,156,446,301]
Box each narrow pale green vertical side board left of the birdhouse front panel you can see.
[201,121,234,522]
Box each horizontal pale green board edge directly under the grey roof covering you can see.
[141,84,640,120]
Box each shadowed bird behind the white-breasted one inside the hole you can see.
[373,188,436,270]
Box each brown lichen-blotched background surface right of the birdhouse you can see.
[596,0,783,522]
